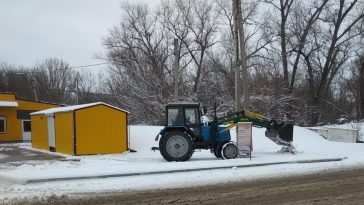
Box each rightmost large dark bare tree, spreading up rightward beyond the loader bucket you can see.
[304,0,364,124]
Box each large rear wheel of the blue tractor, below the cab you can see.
[159,131,193,162]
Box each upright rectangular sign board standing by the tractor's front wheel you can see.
[236,122,253,159]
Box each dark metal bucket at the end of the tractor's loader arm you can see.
[265,124,293,146]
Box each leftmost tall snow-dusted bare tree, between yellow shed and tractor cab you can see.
[104,2,173,124]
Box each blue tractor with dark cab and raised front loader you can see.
[152,103,293,161]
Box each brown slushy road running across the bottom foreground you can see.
[6,168,364,205]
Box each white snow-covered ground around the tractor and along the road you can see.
[0,126,364,202]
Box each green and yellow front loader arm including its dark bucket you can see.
[215,110,293,146]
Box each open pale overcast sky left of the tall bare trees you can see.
[0,0,159,69]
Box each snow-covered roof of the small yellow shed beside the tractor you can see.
[30,102,129,115]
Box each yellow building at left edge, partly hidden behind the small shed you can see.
[0,93,60,142]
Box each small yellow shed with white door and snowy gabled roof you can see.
[31,102,128,155]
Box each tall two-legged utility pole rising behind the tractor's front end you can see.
[232,0,249,111]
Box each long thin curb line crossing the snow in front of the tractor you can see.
[23,157,347,184]
